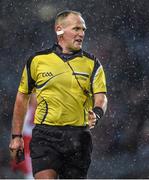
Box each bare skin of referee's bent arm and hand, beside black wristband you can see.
[88,93,107,129]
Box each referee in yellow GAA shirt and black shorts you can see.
[9,10,107,179]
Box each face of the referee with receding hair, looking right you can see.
[60,14,86,53]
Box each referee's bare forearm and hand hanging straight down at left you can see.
[9,92,30,150]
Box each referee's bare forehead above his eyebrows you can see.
[65,14,86,28]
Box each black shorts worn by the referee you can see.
[30,125,92,179]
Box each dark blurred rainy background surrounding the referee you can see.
[0,0,149,179]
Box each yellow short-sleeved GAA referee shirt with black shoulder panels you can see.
[19,44,106,126]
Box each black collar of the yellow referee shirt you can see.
[52,43,83,62]
